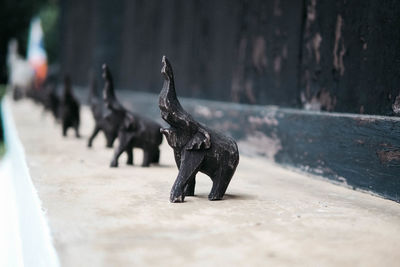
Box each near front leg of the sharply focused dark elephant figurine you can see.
[170,150,204,203]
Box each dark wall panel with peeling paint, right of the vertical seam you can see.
[300,0,400,115]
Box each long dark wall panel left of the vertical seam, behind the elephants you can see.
[61,0,302,106]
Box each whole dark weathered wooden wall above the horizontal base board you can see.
[61,0,400,115]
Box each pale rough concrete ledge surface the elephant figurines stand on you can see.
[8,101,400,267]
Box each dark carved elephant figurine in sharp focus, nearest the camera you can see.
[159,56,239,202]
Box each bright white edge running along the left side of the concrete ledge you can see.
[0,97,60,267]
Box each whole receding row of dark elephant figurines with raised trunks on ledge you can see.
[29,56,239,202]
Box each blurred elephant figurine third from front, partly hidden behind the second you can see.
[87,73,121,148]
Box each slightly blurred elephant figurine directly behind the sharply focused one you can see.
[103,64,162,167]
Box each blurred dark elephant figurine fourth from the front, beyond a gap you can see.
[60,75,80,138]
